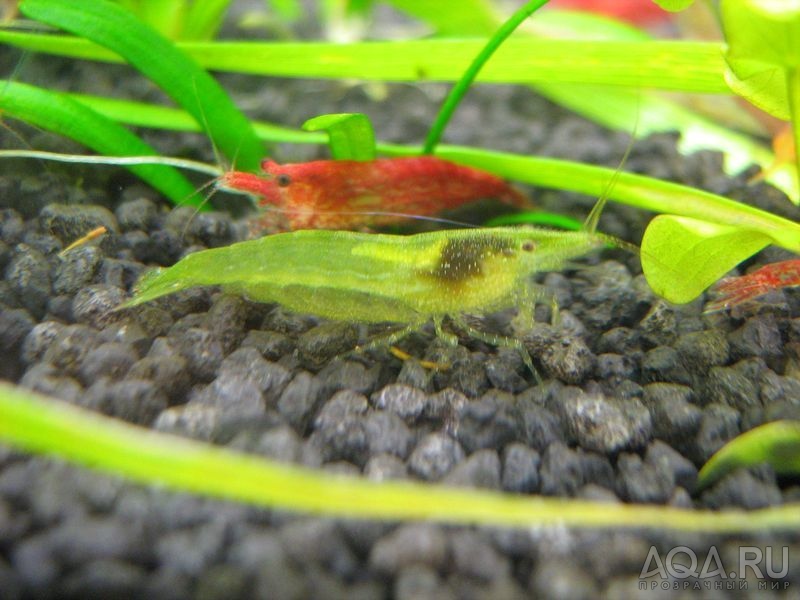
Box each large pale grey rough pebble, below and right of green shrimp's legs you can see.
[561,394,652,454]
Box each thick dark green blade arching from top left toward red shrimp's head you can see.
[20,0,264,170]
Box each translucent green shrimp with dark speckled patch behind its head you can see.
[121,217,621,379]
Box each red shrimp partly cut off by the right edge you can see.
[706,258,800,313]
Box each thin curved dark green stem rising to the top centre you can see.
[422,0,547,154]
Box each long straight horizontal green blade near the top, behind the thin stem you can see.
[0,30,730,94]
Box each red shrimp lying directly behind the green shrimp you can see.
[217,156,530,230]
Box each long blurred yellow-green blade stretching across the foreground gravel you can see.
[0,383,800,532]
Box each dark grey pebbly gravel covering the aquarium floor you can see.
[0,16,800,599]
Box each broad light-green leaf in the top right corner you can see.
[720,0,800,120]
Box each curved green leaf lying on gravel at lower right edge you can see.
[697,421,800,489]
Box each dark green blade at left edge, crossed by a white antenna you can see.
[0,81,202,206]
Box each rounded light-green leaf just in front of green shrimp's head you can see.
[641,215,774,304]
